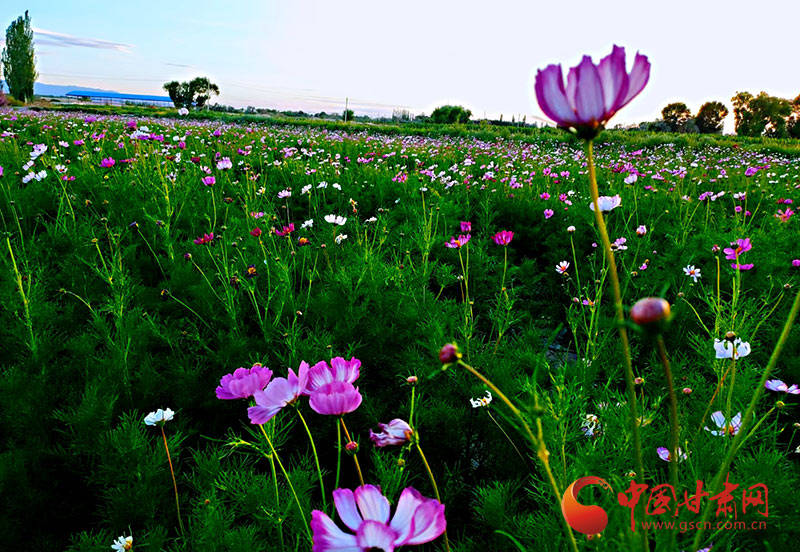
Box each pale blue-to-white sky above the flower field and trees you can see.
[0,0,800,131]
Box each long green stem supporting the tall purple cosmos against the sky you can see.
[586,140,650,550]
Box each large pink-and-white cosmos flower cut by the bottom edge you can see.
[311,485,447,552]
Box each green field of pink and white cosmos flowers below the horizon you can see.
[0,109,800,552]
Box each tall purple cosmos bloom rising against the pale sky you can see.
[535,46,650,139]
